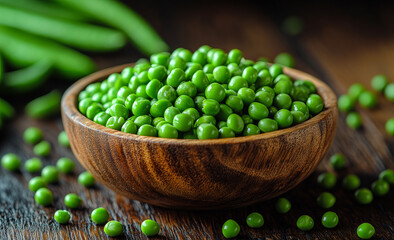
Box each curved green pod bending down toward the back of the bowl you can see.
[56,0,168,55]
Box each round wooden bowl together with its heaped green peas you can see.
[62,46,338,209]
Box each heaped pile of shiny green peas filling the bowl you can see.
[78,45,324,139]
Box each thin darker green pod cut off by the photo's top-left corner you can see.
[0,0,89,21]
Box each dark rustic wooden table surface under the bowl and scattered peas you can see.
[0,1,394,239]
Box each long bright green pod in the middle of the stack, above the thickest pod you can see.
[0,4,126,51]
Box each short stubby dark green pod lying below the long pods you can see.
[3,59,52,93]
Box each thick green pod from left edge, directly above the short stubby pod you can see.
[0,26,95,79]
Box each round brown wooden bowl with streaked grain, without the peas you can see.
[62,64,338,209]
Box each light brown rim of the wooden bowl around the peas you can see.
[61,63,338,145]
